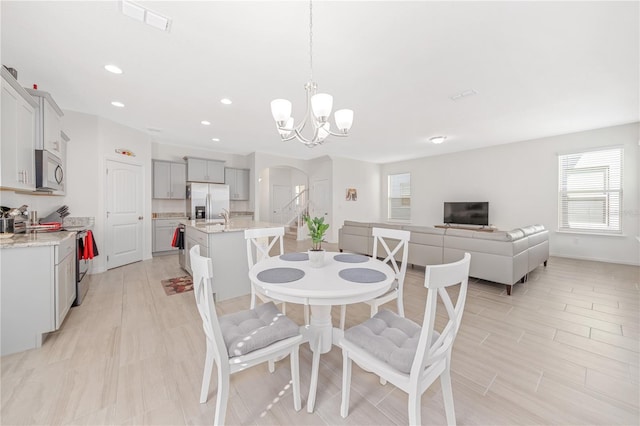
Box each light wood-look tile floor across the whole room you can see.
[0,240,640,425]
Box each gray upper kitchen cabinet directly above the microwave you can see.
[26,89,64,158]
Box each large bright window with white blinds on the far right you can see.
[558,148,622,234]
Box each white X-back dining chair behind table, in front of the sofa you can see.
[340,228,411,330]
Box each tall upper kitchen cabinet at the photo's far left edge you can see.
[0,67,38,191]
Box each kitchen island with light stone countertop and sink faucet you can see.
[183,218,282,301]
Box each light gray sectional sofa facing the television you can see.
[338,221,549,295]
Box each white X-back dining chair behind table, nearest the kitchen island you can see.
[244,227,309,324]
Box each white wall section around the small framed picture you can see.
[332,157,381,238]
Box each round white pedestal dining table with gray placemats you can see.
[249,252,395,412]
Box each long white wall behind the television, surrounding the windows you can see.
[382,123,640,265]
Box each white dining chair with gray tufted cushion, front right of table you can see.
[340,253,471,425]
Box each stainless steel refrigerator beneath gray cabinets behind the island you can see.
[187,182,229,221]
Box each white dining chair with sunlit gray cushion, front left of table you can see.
[189,245,303,425]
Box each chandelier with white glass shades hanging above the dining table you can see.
[271,0,353,148]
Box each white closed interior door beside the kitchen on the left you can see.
[105,160,143,269]
